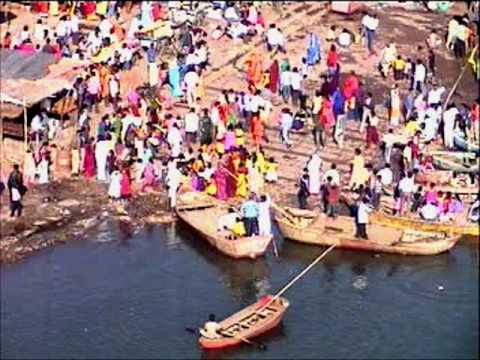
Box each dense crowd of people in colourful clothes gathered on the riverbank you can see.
[2,1,480,242]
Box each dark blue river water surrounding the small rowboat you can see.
[1,224,479,359]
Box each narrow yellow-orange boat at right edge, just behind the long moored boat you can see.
[370,211,480,237]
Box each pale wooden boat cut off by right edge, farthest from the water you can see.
[429,151,480,173]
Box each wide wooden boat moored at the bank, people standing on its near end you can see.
[175,192,272,259]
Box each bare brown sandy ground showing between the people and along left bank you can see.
[0,2,477,262]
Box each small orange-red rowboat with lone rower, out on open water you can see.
[198,295,290,349]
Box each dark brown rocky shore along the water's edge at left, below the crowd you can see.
[0,179,175,264]
